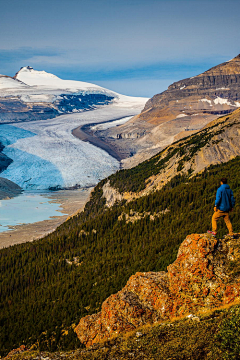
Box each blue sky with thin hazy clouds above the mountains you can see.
[0,0,240,97]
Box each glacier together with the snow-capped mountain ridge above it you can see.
[0,66,148,190]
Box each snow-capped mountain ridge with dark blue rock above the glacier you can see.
[0,66,148,123]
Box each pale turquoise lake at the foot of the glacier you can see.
[0,191,64,232]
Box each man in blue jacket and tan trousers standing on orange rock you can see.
[208,178,235,237]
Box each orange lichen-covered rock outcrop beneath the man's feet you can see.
[75,234,240,346]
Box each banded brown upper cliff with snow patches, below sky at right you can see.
[142,55,240,123]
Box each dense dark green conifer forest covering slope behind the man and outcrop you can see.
[0,157,240,358]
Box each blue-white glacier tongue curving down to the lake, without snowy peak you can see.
[0,104,144,190]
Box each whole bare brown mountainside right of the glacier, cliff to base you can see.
[98,55,240,168]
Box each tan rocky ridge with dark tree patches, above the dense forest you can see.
[103,109,240,202]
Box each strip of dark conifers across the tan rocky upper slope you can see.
[109,116,239,193]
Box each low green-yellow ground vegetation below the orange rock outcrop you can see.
[7,305,240,360]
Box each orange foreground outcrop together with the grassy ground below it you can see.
[4,234,240,360]
